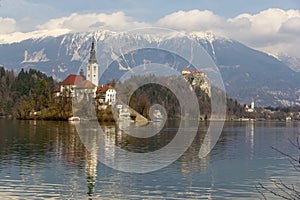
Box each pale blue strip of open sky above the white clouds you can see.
[0,0,300,22]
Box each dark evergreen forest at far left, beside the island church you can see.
[0,67,56,118]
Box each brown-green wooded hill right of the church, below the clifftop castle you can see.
[116,75,245,120]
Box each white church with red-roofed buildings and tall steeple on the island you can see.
[54,41,117,105]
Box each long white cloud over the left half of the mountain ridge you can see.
[0,12,150,43]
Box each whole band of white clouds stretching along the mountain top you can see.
[0,8,300,57]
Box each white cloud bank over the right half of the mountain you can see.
[157,8,300,57]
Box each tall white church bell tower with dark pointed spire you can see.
[86,41,99,85]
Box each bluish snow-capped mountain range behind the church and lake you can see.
[0,30,300,106]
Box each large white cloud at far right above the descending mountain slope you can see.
[226,8,300,57]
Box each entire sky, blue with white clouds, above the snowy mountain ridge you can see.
[0,0,300,58]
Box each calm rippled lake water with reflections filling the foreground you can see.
[0,119,300,199]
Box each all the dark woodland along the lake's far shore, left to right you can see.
[0,67,300,120]
